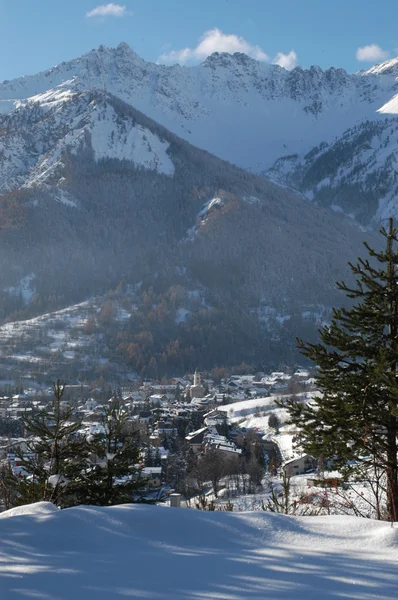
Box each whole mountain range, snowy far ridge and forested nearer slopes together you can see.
[0,44,388,364]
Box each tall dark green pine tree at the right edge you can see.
[287,219,398,521]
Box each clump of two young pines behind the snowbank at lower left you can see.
[11,380,145,508]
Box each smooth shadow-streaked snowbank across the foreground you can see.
[0,503,398,600]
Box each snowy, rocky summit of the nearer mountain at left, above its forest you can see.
[0,92,174,193]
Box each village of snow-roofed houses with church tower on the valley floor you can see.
[0,368,332,510]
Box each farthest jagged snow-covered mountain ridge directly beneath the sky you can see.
[0,44,397,172]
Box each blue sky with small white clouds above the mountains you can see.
[0,0,398,81]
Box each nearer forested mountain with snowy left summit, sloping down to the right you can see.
[0,85,376,370]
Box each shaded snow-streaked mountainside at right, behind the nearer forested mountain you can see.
[269,118,398,227]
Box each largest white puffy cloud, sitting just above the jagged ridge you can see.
[158,27,269,65]
